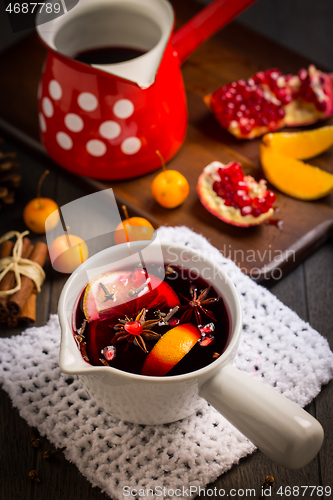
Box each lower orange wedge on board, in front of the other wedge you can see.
[260,144,333,200]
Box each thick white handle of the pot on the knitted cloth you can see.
[200,365,324,469]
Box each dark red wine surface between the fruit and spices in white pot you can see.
[74,266,231,376]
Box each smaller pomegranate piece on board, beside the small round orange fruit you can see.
[197,161,276,227]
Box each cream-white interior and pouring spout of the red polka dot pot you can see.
[36,0,174,88]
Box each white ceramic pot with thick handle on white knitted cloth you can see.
[58,241,324,469]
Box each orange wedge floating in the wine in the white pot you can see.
[141,323,201,377]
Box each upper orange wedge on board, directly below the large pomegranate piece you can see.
[262,125,333,160]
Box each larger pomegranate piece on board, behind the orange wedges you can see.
[204,65,333,139]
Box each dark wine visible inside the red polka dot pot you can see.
[73,46,145,64]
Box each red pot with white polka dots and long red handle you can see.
[37,0,260,180]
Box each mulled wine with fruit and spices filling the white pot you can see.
[73,265,231,376]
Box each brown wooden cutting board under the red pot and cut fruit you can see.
[0,1,333,283]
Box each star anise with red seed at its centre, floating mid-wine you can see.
[111,308,161,352]
